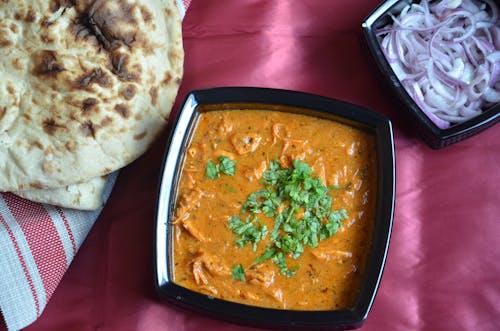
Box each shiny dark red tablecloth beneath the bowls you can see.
[14,0,500,331]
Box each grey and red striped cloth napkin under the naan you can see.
[0,0,191,330]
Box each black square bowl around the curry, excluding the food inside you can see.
[155,87,395,330]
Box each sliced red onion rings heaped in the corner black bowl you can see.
[377,0,500,129]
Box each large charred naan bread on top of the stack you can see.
[0,0,184,191]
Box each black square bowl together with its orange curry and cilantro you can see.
[156,88,394,326]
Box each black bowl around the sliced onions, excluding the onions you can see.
[362,0,500,149]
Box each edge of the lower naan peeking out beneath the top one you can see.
[13,176,107,210]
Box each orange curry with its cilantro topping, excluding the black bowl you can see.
[173,110,376,310]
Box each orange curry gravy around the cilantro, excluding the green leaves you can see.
[173,110,376,310]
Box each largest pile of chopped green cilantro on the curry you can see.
[229,159,347,277]
